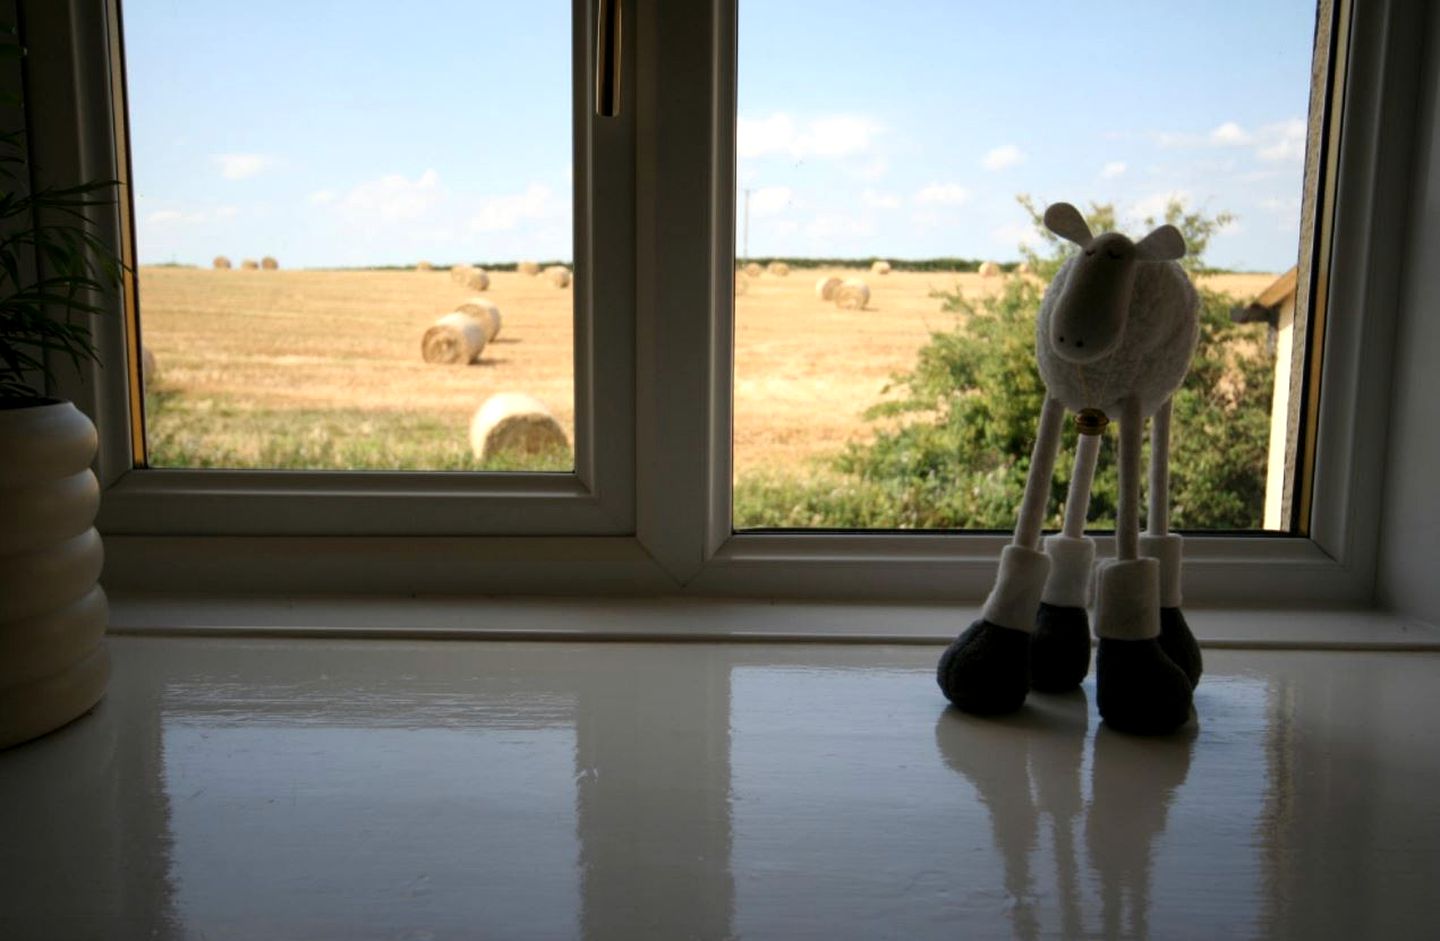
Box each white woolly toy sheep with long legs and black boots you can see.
[937,203,1201,733]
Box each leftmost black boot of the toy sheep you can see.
[936,620,1030,716]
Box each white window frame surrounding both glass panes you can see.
[23,0,1424,605]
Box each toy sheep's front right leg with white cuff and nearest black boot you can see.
[1096,398,1192,733]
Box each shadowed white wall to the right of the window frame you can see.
[1375,6,1440,624]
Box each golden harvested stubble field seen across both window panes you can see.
[140,268,1274,474]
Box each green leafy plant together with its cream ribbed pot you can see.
[0,87,121,748]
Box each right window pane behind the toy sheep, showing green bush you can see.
[734,0,1316,530]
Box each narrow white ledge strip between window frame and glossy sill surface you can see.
[109,594,1440,650]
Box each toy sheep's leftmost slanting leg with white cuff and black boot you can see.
[936,398,1064,715]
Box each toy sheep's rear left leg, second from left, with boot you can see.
[1030,432,1100,693]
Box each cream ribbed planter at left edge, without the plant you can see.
[0,399,109,748]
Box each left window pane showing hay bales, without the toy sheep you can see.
[124,0,575,470]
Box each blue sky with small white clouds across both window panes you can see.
[124,0,1315,271]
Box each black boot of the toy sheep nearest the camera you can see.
[1094,637,1192,735]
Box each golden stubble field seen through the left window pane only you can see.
[140,268,575,470]
